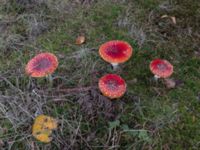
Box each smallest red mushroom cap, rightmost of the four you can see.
[150,59,173,78]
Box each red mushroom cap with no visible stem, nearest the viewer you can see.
[99,74,126,99]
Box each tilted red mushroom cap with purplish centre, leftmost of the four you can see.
[25,53,58,77]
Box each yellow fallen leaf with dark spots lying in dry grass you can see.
[32,115,57,143]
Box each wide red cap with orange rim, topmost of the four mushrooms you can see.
[99,40,133,63]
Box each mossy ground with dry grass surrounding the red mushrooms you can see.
[0,0,200,150]
